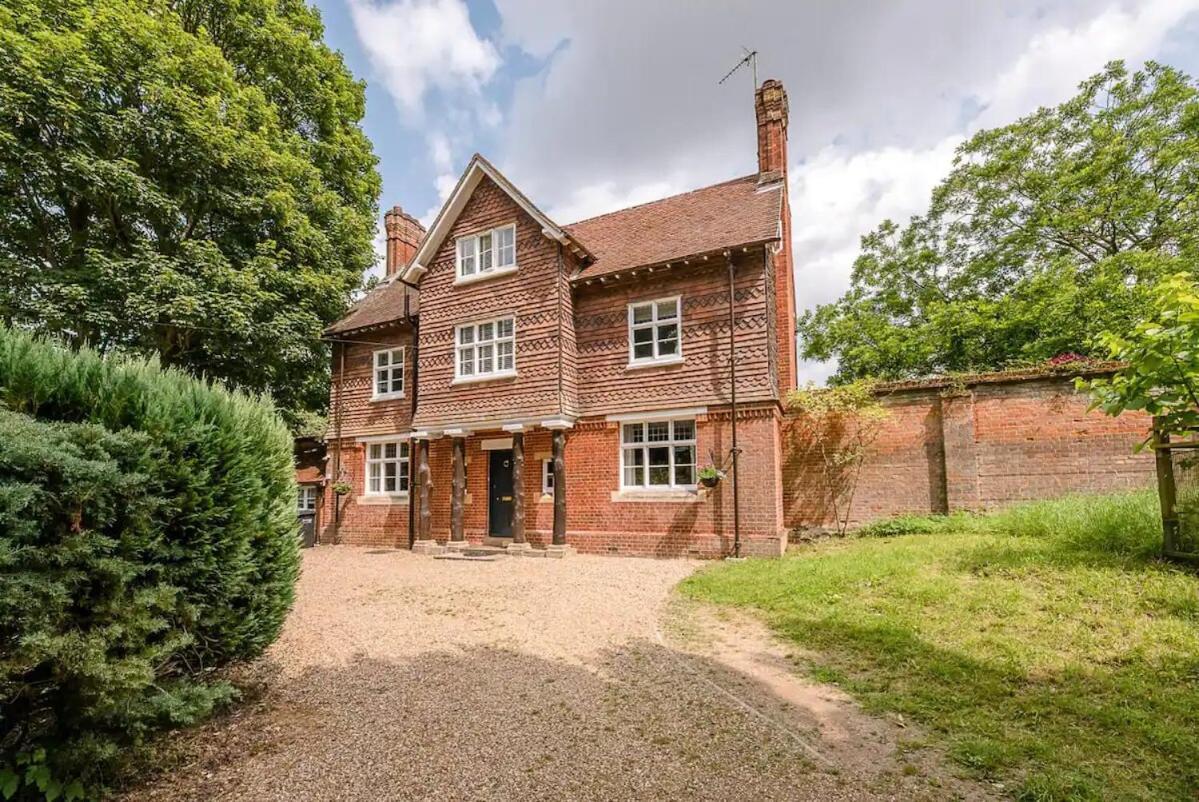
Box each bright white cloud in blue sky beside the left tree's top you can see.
[348,0,500,121]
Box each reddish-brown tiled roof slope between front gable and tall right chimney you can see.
[562,173,783,277]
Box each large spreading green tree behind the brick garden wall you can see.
[799,62,1199,381]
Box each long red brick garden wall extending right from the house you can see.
[783,374,1153,529]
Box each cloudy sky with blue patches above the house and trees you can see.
[317,0,1199,380]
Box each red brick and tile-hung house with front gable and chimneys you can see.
[318,80,796,556]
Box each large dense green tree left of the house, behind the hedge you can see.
[0,0,379,421]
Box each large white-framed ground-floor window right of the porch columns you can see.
[620,418,695,489]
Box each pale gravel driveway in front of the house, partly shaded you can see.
[127,547,975,800]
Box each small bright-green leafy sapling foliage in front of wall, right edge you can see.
[1079,273,1199,441]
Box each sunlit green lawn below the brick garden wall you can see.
[682,494,1199,800]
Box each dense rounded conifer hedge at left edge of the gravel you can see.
[0,327,299,798]
